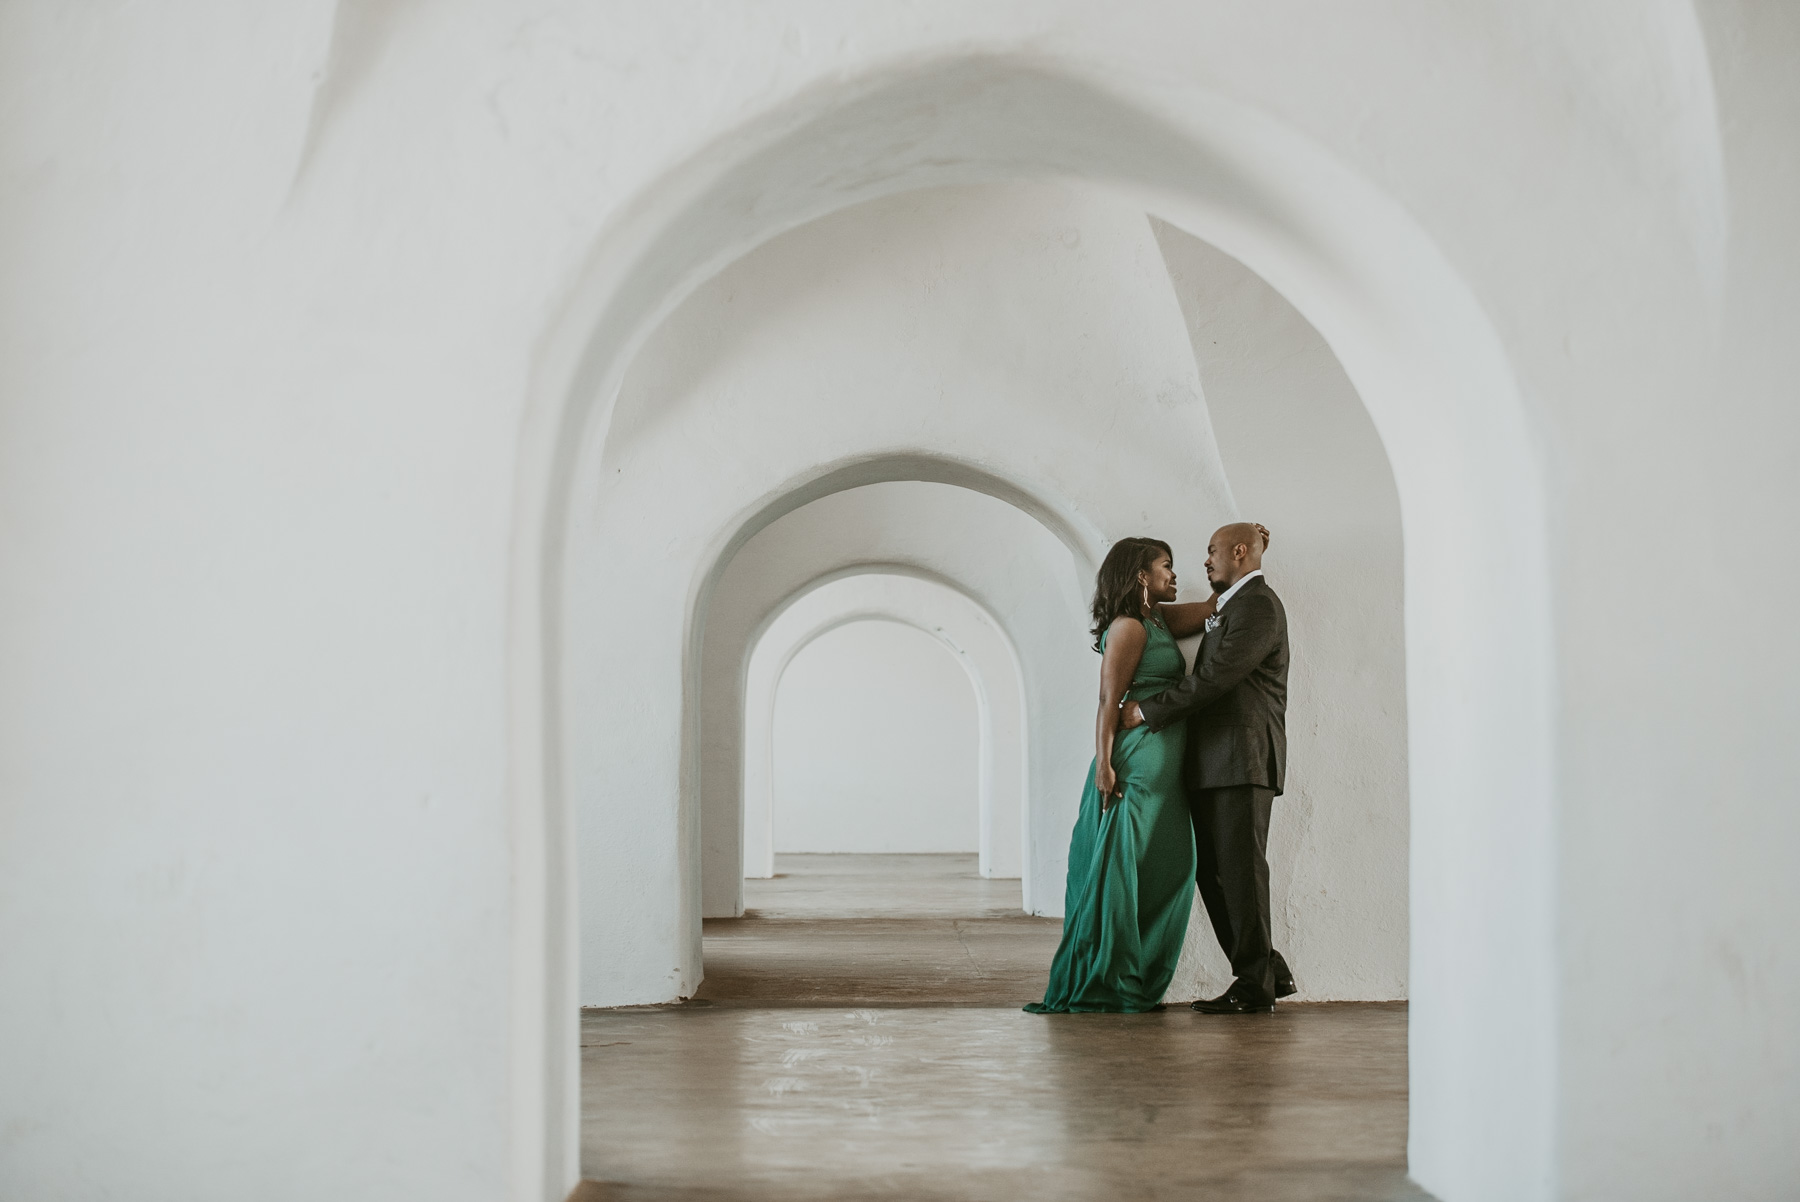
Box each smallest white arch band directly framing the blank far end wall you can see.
[743,572,1028,892]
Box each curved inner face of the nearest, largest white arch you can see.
[511,58,1555,1197]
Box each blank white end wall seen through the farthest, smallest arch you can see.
[774,619,981,853]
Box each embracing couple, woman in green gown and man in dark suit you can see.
[1026,522,1294,1015]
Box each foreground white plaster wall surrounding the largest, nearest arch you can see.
[0,9,1800,1202]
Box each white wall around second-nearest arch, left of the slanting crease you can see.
[563,185,1233,1006]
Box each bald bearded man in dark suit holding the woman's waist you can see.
[1121,522,1294,1015]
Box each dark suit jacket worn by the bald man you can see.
[1138,576,1287,794]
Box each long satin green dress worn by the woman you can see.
[1026,619,1195,1015]
